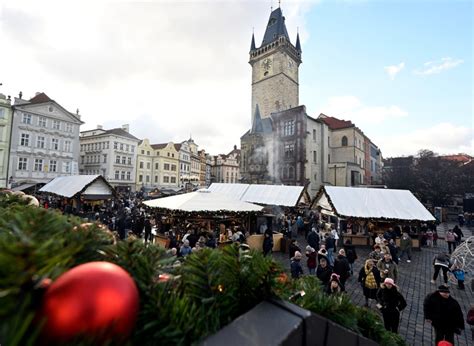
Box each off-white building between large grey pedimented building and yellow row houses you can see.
[79,125,140,191]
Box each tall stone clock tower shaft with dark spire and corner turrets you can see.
[249,8,301,123]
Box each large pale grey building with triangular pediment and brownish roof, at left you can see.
[8,93,83,186]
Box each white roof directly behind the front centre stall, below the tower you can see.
[209,183,304,207]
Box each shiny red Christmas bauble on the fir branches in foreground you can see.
[40,262,139,342]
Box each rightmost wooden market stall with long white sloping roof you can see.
[312,186,435,248]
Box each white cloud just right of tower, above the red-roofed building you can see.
[320,95,408,128]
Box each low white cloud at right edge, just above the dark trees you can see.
[374,122,474,157]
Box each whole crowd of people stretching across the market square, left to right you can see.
[31,194,474,344]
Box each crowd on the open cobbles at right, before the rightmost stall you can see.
[289,219,474,345]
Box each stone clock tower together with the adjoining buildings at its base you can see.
[241,8,381,196]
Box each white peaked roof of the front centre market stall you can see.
[143,189,263,213]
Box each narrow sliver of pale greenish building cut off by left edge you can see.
[0,94,13,188]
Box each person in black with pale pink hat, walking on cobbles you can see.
[377,278,407,333]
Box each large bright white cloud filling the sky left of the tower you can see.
[0,0,318,154]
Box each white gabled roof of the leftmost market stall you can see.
[39,175,114,199]
